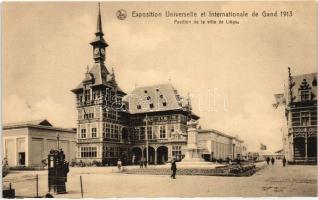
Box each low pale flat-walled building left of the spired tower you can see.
[2,120,76,167]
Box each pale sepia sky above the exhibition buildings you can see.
[2,2,317,151]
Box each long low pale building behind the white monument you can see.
[198,129,246,160]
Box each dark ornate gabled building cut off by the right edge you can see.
[276,69,317,164]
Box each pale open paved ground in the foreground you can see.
[4,162,317,198]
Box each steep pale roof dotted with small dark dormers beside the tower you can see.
[125,83,184,114]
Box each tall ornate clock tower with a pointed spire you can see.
[72,6,129,165]
